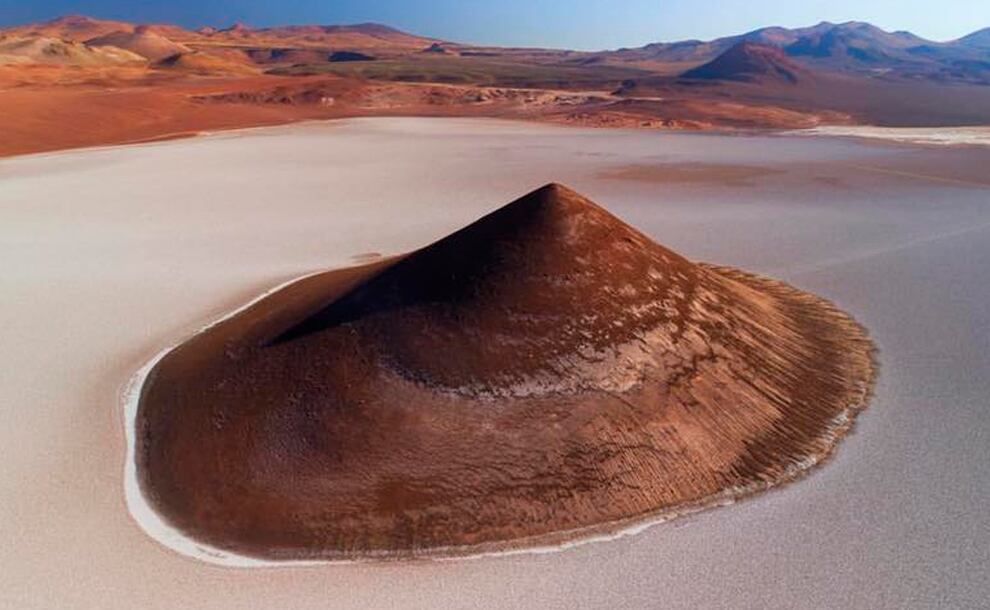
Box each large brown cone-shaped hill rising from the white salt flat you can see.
[135,185,873,559]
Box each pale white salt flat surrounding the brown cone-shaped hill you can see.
[0,119,990,608]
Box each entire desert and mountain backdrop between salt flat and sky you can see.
[0,16,990,155]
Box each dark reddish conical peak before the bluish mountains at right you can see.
[682,41,806,84]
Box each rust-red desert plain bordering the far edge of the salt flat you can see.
[0,64,845,156]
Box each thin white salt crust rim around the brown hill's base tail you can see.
[121,270,869,568]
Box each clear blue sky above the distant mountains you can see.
[0,0,990,49]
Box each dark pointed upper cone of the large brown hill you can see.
[272,184,699,396]
